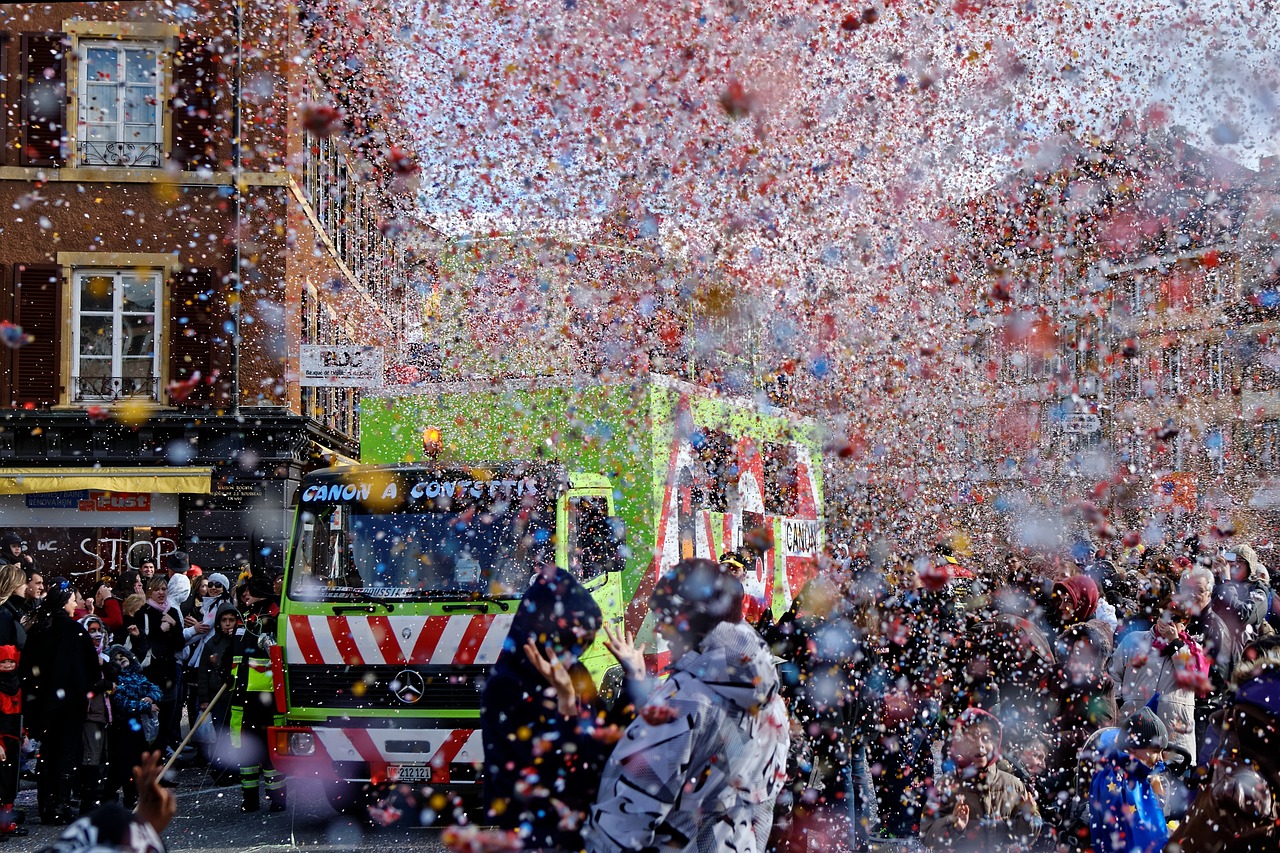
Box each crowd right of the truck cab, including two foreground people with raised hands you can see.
[471,539,1280,853]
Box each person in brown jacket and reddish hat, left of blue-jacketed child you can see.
[920,708,1043,853]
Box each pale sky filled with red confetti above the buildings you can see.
[391,0,1280,254]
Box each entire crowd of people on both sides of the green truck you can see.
[10,525,1280,853]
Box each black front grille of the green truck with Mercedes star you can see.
[288,663,490,711]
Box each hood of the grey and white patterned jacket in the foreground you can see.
[671,622,778,713]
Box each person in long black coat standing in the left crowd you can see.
[22,578,101,825]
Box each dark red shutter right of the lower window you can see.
[168,268,227,406]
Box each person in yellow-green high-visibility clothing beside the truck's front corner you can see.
[230,574,285,812]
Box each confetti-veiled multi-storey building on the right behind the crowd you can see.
[957,124,1280,540]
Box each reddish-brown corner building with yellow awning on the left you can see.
[0,0,416,573]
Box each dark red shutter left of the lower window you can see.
[9,264,63,407]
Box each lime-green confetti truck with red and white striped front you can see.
[269,375,823,809]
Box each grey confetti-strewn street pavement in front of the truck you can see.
[17,770,445,853]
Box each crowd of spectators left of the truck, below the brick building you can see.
[0,533,284,840]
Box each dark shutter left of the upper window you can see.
[22,32,67,167]
